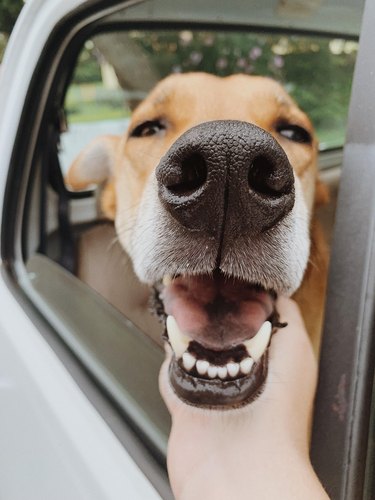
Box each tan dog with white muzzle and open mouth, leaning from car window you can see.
[67,73,328,408]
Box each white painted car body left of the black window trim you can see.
[0,0,160,500]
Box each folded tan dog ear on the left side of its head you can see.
[65,135,121,220]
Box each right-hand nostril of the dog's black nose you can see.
[248,155,291,197]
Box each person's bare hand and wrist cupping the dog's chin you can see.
[160,297,328,500]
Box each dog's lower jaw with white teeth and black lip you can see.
[165,313,283,410]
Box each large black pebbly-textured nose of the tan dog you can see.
[156,120,294,237]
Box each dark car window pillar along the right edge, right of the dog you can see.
[311,0,375,500]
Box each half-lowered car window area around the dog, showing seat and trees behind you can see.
[24,25,357,466]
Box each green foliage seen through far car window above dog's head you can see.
[131,31,357,146]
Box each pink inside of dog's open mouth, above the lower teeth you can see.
[161,273,274,350]
